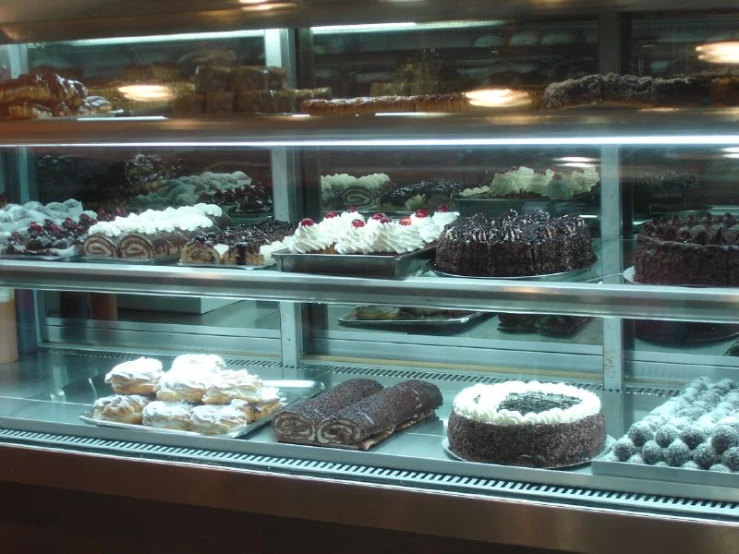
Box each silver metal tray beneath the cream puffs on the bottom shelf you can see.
[80,379,323,439]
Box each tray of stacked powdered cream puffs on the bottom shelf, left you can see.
[80,354,323,438]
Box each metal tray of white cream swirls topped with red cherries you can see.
[273,206,457,277]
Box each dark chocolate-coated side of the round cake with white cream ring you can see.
[447,410,606,467]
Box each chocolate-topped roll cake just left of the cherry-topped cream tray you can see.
[180,220,296,265]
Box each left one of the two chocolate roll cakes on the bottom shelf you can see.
[272,379,382,442]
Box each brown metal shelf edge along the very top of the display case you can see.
[0,0,736,43]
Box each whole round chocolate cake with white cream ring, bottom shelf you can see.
[447,381,606,467]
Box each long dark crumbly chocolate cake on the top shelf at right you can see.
[541,73,708,110]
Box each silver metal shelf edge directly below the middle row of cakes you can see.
[0,261,739,323]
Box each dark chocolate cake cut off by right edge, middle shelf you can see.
[634,213,739,287]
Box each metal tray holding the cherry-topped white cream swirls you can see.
[272,245,436,277]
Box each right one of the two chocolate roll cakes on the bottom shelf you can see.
[316,380,442,450]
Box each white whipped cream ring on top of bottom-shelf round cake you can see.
[454,381,601,425]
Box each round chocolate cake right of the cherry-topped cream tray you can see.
[436,210,595,277]
